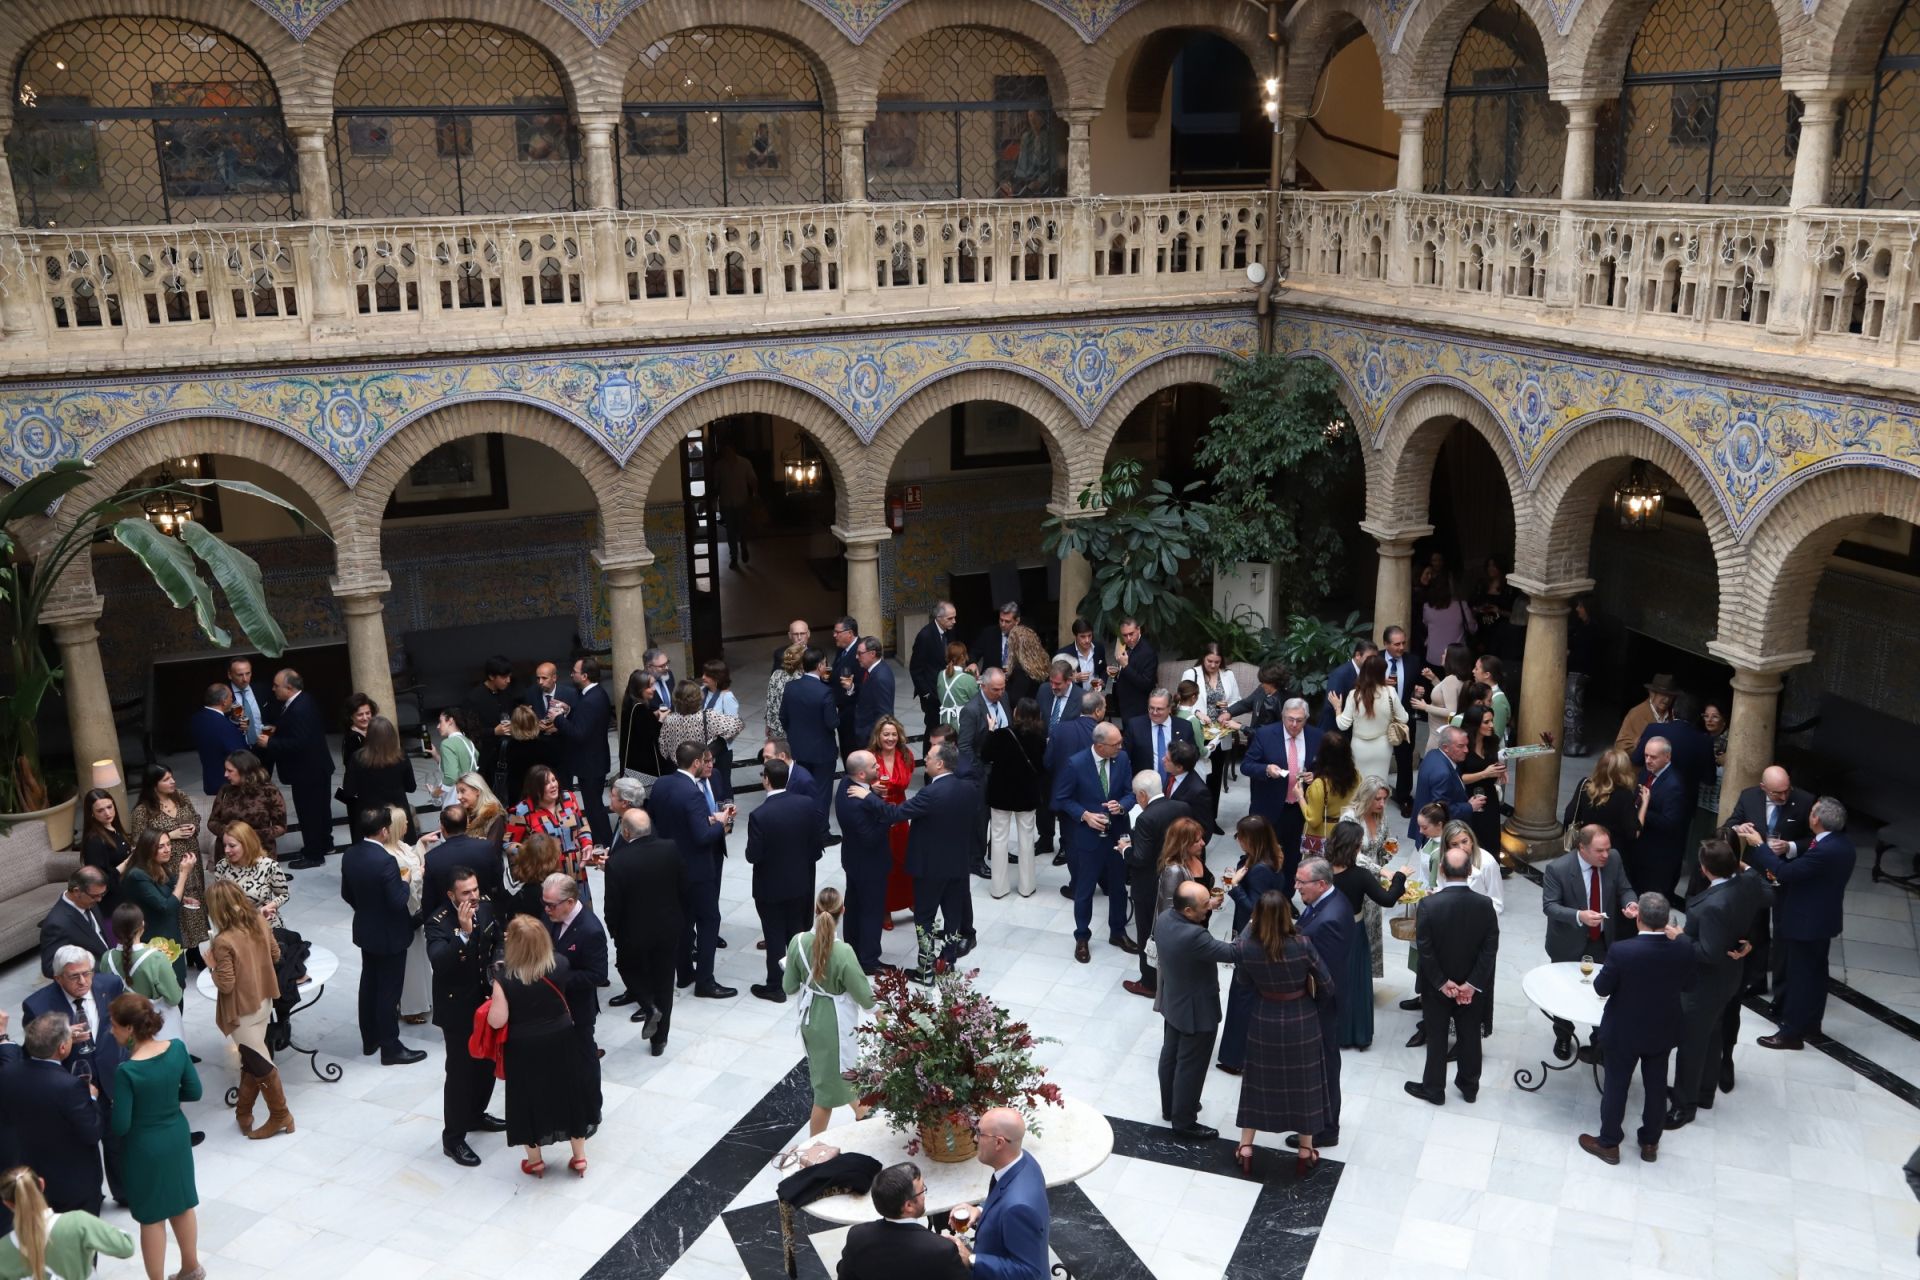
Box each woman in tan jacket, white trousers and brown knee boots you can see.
[207,879,294,1138]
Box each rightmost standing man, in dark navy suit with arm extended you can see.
[1745,796,1855,1050]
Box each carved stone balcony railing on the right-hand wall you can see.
[1279,192,1920,367]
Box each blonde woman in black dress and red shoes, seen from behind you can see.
[486,917,601,1178]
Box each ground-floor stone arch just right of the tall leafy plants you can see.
[1361,378,1532,530]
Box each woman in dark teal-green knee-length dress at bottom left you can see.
[108,992,207,1280]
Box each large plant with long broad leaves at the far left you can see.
[0,459,307,848]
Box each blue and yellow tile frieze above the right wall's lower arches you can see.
[1277,311,1920,533]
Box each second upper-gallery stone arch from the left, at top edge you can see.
[307,0,602,115]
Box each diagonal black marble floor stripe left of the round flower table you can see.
[586,1057,802,1280]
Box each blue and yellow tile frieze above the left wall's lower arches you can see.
[0,309,1258,484]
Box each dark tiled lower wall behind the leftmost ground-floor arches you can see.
[94,505,685,702]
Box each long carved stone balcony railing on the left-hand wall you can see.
[0,192,1269,365]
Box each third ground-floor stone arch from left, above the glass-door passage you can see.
[620,378,867,528]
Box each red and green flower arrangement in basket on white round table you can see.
[849,961,1062,1163]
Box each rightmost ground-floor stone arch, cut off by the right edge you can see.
[1720,462,1920,654]
